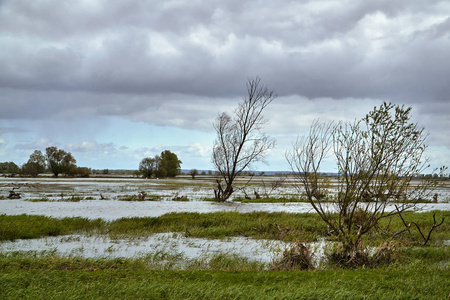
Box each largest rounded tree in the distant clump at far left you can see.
[45,146,77,177]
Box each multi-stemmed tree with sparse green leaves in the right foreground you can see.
[286,103,442,259]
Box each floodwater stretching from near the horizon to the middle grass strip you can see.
[0,177,450,220]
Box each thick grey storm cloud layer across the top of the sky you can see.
[0,1,450,101]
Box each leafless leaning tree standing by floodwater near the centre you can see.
[212,77,276,201]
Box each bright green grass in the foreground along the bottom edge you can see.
[0,248,450,299]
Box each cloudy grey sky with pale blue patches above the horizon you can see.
[0,0,450,172]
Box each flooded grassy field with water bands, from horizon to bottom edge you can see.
[0,176,450,299]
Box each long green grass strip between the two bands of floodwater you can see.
[0,211,450,246]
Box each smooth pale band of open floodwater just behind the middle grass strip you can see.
[0,199,450,220]
